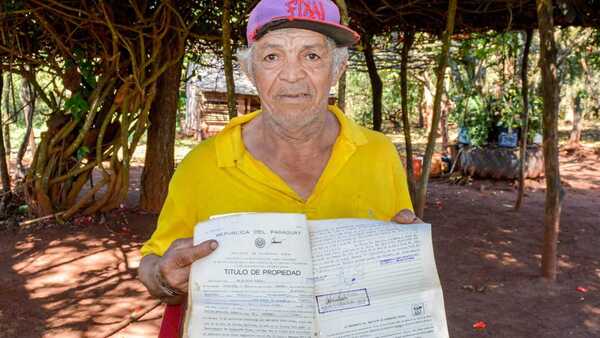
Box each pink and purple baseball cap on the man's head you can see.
[246,0,360,47]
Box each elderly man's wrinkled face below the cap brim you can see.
[252,28,334,129]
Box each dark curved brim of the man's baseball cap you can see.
[255,17,360,47]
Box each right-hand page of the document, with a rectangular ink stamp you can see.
[309,219,448,338]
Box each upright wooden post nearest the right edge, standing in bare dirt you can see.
[536,0,561,281]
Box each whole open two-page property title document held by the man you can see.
[184,213,448,338]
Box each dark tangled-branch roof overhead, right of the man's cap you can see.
[346,0,600,34]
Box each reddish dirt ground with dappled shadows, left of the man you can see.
[0,207,161,337]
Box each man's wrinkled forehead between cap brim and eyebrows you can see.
[255,28,327,50]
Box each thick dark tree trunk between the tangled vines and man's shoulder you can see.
[140,57,183,213]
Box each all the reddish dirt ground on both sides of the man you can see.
[0,148,600,338]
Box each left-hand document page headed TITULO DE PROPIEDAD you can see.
[186,214,314,337]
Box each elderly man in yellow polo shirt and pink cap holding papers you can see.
[139,0,416,304]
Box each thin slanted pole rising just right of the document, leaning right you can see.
[415,0,457,219]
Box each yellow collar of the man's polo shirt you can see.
[215,106,367,167]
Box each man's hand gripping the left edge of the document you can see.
[139,238,219,304]
